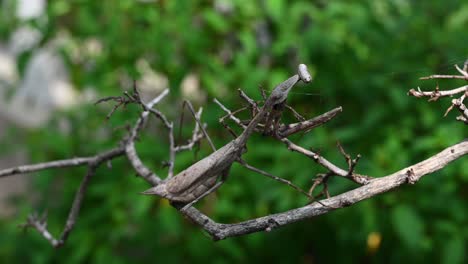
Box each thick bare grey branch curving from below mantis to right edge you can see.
[199,140,468,240]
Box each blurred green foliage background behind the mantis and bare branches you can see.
[0,0,468,263]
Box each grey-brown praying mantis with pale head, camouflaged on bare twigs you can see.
[143,64,312,208]
